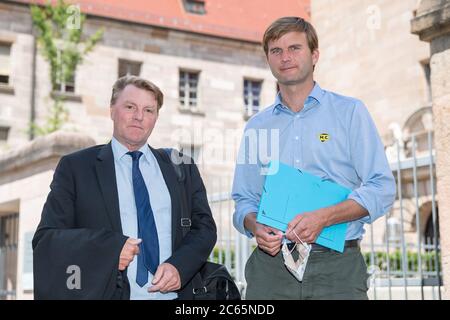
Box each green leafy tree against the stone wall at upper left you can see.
[30,0,104,135]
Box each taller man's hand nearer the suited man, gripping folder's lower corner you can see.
[244,213,283,256]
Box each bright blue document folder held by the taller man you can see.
[256,162,351,252]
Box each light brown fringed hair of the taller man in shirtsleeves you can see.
[263,17,319,56]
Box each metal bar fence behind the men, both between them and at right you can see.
[208,132,442,300]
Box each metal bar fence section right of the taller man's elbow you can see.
[362,132,442,300]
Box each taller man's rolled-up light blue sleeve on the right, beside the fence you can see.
[348,101,396,223]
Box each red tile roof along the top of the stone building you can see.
[16,0,310,42]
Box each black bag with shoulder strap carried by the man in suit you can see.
[158,149,241,300]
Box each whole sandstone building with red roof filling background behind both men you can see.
[0,0,445,299]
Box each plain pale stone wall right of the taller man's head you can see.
[311,0,434,256]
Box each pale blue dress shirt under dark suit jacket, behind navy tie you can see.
[111,137,178,300]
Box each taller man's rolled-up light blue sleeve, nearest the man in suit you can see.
[231,128,264,237]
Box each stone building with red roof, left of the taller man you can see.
[0,0,309,299]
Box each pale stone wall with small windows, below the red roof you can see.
[0,4,276,190]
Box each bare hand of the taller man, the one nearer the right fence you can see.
[286,209,327,243]
